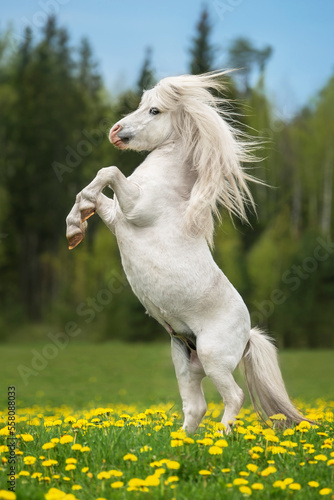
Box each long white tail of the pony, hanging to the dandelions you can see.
[241,328,314,425]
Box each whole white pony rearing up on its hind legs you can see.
[67,72,310,432]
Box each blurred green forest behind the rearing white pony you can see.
[0,9,334,348]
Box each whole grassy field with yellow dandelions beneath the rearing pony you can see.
[0,342,334,500]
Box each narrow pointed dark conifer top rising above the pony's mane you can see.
[189,7,215,75]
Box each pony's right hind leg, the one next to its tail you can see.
[197,334,245,432]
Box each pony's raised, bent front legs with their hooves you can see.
[66,167,140,250]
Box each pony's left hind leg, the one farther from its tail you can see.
[172,338,207,432]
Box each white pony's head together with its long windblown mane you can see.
[109,71,258,244]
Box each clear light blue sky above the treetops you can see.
[0,0,334,117]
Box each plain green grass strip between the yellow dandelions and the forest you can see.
[0,342,334,407]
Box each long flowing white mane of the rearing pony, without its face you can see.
[150,72,258,245]
